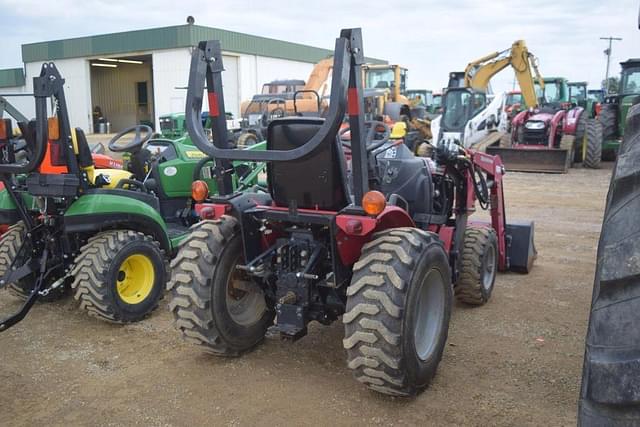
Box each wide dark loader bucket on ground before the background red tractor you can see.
[487,146,571,173]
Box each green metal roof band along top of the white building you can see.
[22,25,385,63]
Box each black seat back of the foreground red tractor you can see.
[267,117,350,211]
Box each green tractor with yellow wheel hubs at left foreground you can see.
[0,63,260,331]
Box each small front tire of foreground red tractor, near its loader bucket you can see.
[453,227,498,305]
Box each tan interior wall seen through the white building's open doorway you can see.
[91,56,154,132]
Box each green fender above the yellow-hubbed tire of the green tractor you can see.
[64,192,171,252]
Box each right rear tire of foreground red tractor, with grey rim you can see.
[342,228,453,396]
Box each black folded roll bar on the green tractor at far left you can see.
[0,62,69,174]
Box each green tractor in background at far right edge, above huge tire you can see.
[599,58,640,158]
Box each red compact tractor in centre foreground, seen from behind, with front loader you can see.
[169,29,535,396]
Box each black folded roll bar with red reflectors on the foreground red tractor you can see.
[185,28,368,200]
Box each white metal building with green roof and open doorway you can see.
[0,25,348,133]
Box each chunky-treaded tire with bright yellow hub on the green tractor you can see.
[71,230,167,323]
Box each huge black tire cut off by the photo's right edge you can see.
[578,101,640,426]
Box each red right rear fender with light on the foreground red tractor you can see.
[336,206,415,265]
